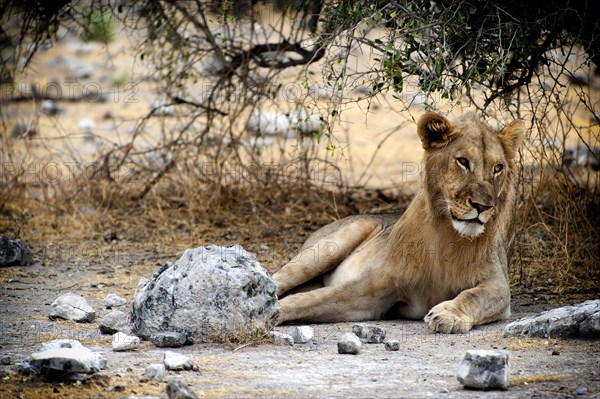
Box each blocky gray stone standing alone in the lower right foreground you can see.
[456,350,509,389]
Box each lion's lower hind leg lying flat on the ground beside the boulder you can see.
[278,282,381,324]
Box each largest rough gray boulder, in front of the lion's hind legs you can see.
[131,245,279,343]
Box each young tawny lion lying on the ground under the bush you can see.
[273,113,525,333]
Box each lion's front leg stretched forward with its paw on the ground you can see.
[425,279,510,333]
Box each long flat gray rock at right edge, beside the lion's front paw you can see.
[504,299,600,338]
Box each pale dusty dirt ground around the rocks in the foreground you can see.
[0,234,600,398]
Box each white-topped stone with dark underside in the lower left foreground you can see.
[26,340,106,380]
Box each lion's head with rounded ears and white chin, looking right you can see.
[417,113,525,238]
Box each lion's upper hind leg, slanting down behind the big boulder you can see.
[273,219,379,296]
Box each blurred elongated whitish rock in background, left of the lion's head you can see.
[246,108,325,137]
